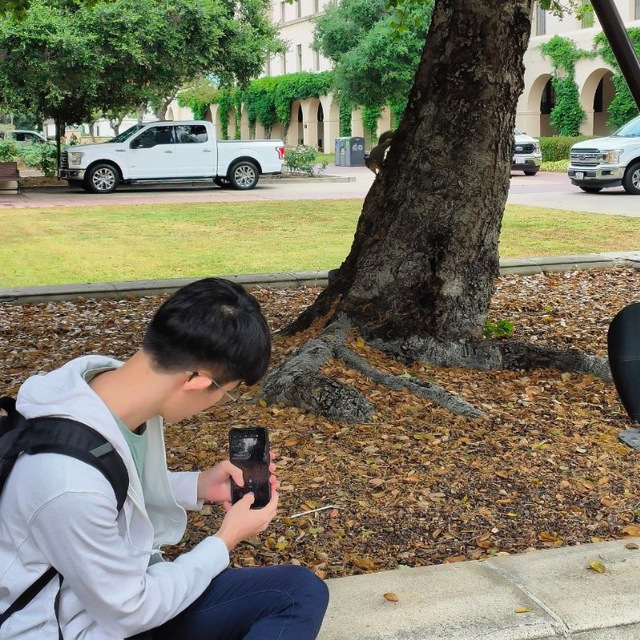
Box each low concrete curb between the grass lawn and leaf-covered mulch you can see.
[0,251,640,304]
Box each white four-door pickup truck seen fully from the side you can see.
[60,120,285,193]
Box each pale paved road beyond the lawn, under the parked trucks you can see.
[0,165,640,216]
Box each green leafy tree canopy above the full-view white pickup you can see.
[0,0,280,123]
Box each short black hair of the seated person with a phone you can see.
[142,278,271,385]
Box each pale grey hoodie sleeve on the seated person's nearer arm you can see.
[21,454,229,637]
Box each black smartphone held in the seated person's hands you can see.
[229,427,271,509]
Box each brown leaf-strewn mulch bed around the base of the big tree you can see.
[0,267,640,577]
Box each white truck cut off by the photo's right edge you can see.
[567,116,640,196]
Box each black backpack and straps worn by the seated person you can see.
[0,397,129,637]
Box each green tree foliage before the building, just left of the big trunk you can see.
[313,0,433,107]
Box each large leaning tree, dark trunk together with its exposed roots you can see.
[263,0,609,421]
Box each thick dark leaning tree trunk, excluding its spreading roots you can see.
[288,0,531,348]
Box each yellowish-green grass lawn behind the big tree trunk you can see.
[0,200,640,288]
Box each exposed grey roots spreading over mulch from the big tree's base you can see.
[260,315,612,423]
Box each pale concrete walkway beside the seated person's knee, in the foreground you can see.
[318,538,640,640]
